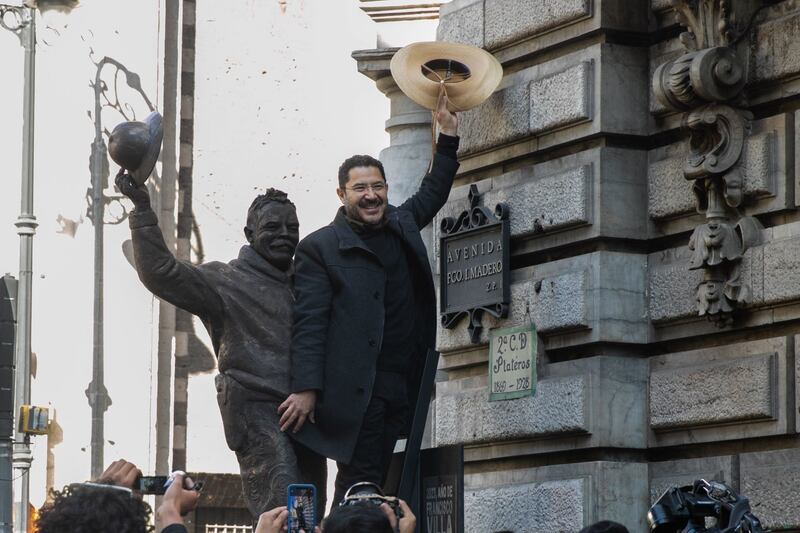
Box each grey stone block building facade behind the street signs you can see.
[354,0,800,532]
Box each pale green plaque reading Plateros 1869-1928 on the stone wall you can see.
[489,324,536,402]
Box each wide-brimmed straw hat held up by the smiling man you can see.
[390,42,503,111]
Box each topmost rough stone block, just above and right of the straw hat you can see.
[486,0,592,48]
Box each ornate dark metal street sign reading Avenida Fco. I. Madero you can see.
[439,184,510,344]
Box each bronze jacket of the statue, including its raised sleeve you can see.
[130,210,294,401]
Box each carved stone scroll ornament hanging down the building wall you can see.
[653,0,762,327]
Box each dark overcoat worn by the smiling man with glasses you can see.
[290,153,458,463]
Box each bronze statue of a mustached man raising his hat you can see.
[109,113,327,520]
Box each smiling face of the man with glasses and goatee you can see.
[336,167,389,224]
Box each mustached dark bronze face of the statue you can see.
[245,202,300,270]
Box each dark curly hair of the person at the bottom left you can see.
[36,484,154,533]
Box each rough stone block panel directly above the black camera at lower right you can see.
[650,455,746,504]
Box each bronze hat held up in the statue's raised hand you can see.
[108,111,164,185]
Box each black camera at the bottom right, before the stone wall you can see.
[647,479,766,533]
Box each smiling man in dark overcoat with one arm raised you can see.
[279,96,458,504]
